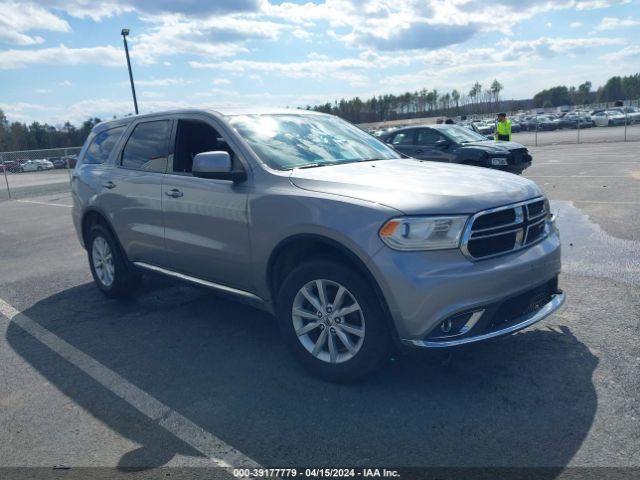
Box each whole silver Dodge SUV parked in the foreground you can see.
[72,110,564,381]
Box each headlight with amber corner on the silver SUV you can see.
[379,216,468,251]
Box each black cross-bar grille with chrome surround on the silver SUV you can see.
[461,198,549,260]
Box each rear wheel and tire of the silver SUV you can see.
[87,225,141,298]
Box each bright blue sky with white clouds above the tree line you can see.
[0,0,640,126]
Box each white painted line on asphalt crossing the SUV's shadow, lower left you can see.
[0,298,262,474]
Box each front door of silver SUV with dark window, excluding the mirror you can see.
[162,115,254,291]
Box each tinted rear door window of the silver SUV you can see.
[121,120,171,173]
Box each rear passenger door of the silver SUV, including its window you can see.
[100,120,172,264]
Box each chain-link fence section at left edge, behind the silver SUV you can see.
[0,147,82,199]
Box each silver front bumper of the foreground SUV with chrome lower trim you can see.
[369,228,564,347]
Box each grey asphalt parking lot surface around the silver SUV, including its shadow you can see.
[0,139,640,478]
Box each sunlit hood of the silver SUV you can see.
[289,159,542,215]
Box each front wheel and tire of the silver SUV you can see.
[277,260,391,383]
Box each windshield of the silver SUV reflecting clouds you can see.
[230,114,400,170]
